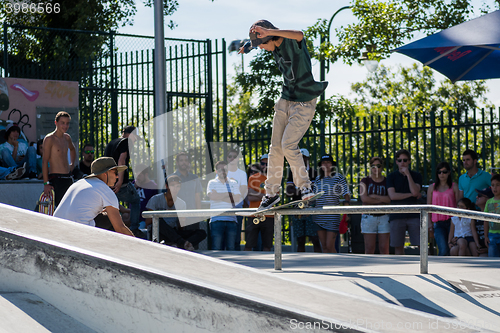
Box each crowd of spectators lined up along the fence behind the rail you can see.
[0,118,500,256]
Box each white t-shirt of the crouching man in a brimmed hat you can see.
[54,177,119,227]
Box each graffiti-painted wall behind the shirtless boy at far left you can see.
[0,77,78,143]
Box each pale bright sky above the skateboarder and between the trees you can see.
[118,0,500,107]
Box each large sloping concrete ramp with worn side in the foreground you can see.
[0,204,494,332]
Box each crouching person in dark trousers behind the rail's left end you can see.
[146,172,207,251]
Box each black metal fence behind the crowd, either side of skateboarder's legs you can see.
[228,109,500,193]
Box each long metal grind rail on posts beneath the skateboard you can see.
[142,205,500,274]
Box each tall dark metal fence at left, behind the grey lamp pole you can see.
[0,23,227,173]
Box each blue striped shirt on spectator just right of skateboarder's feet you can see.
[312,173,351,232]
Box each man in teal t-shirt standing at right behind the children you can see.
[458,149,491,204]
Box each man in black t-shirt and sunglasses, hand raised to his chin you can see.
[387,149,422,255]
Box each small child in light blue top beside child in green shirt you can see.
[448,198,477,256]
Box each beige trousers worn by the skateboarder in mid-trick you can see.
[265,98,317,196]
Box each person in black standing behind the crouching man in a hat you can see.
[104,126,146,239]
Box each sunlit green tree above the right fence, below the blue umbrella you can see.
[348,64,491,118]
